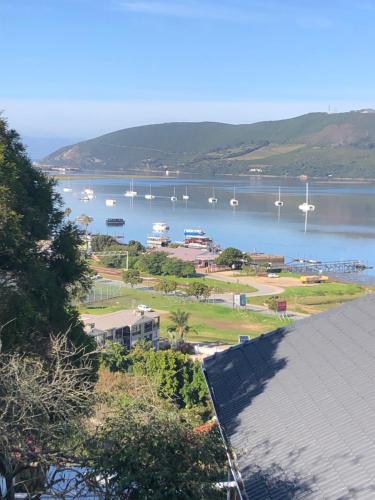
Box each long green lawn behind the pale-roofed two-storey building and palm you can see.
[81,289,286,344]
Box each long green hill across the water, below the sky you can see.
[41,110,375,178]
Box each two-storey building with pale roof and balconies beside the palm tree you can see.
[81,309,160,349]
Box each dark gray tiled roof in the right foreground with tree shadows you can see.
[203,293,375,500]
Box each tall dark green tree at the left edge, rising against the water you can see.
[0,118,93,353]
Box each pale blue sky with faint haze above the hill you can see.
[0,0,375,154]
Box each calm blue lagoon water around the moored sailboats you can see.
[58,177,375,282]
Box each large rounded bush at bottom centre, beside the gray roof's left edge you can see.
[90,398,226,500]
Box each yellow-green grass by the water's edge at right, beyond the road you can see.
[249,283,366,314]
